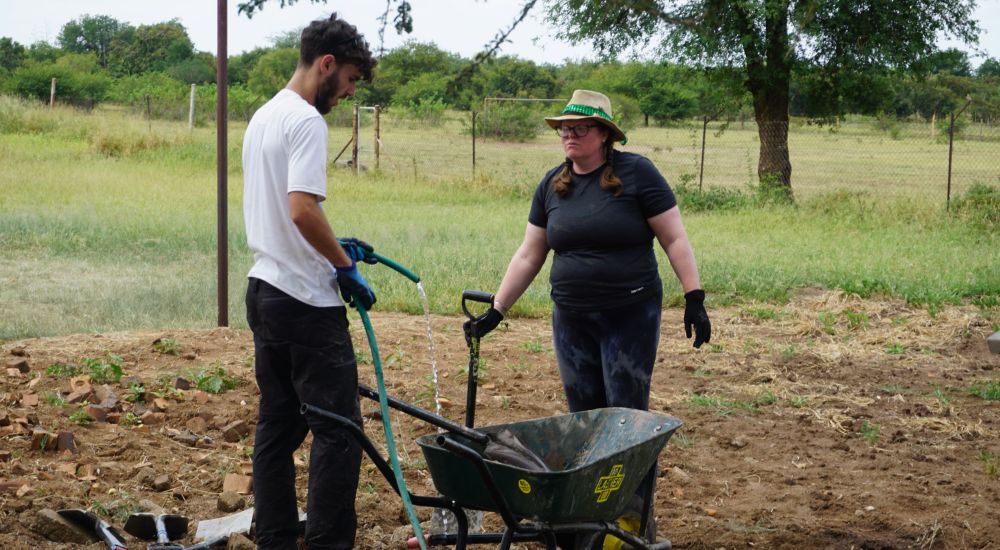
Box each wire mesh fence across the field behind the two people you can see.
[344,109,1000,203]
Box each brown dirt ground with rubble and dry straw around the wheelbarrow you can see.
[0,291,1000,549]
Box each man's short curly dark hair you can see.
[299,13,378,81]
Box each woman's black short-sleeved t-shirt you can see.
[528,151,677,310]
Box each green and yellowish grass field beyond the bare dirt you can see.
[0,98,1000,340]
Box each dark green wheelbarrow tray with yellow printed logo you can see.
[417,407,682,524]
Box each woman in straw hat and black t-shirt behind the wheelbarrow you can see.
[465,90,712,548]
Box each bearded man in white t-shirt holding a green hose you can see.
[243,14,376,549]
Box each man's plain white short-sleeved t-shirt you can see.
[243,89,344,307]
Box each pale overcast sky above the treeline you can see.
[0,0,1000,66]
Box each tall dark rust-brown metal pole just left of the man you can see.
[215,0,229,327]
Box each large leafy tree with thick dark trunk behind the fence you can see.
[548,0,979,196]
